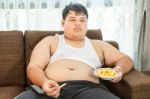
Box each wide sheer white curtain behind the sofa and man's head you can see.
[0,0,144,69]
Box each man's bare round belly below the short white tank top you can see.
[45,60,99,83]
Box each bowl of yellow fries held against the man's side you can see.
[94,68,117,80]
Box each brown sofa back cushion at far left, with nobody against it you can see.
[0,31,25,85]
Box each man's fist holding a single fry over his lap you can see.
[42,80,60,98]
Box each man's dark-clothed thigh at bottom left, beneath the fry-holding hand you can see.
[15,89,54,99]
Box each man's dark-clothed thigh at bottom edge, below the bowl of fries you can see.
[74,88,120,99]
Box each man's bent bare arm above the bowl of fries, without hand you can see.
[101,42,133,74]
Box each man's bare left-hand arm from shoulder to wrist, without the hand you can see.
[27,37,51,87]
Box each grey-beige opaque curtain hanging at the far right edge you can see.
[138,0,150,71]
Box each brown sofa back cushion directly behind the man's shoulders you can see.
[25,29,102,84]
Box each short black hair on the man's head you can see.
[62,3,88,20]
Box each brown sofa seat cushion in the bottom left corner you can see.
[0,86,24,99]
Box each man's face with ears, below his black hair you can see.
[62,11,88,39]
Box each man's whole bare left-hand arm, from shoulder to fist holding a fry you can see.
[27,37,60,97]
